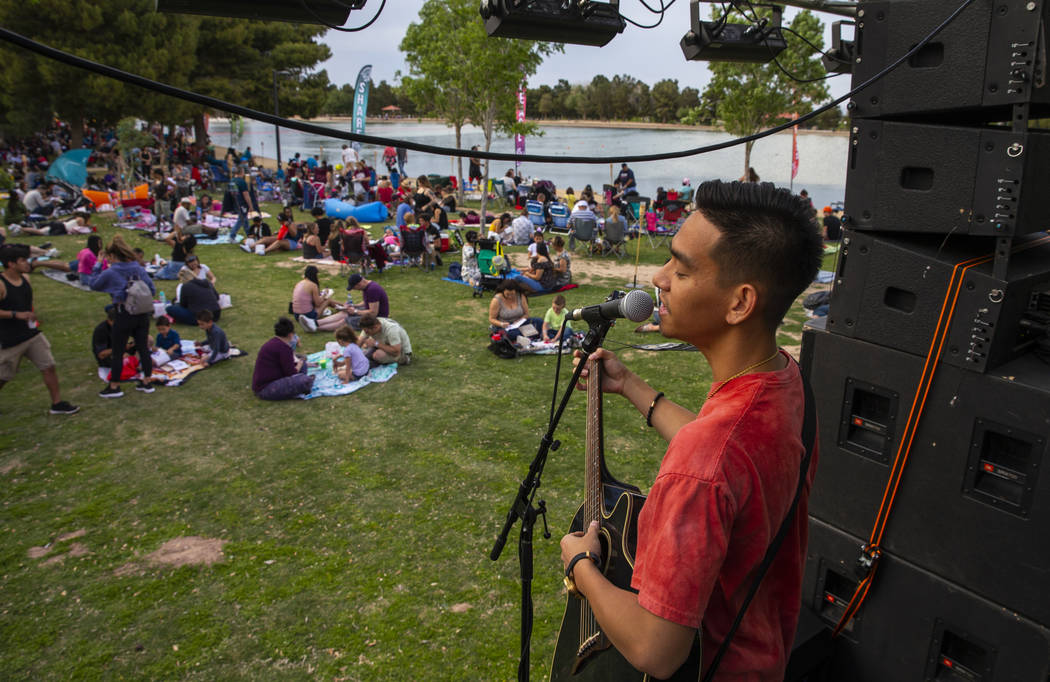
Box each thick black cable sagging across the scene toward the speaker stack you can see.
[0,0,974,165]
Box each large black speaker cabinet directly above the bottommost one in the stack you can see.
[802,328,1050,624]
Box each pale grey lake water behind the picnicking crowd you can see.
[209,119,848,208]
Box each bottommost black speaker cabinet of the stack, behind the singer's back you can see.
[802,517,1050,682]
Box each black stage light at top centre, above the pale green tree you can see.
[479,0,627,47]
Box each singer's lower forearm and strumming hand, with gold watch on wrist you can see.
[562,521,696,679]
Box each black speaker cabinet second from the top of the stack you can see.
[843,119,1050,237]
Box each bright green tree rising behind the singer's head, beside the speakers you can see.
[704,8,827,174]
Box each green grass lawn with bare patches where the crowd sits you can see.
[0,206,831,680]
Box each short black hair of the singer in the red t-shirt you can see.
[694,180,823,329]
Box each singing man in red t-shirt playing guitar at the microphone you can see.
[562,180,822,682]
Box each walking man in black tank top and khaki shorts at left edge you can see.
[0,244,80,414]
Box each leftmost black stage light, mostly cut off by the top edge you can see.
[153,0,365,26]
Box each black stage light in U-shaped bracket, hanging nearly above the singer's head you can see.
[679,0,788,64]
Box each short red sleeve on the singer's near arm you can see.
[631,473,734,627]
